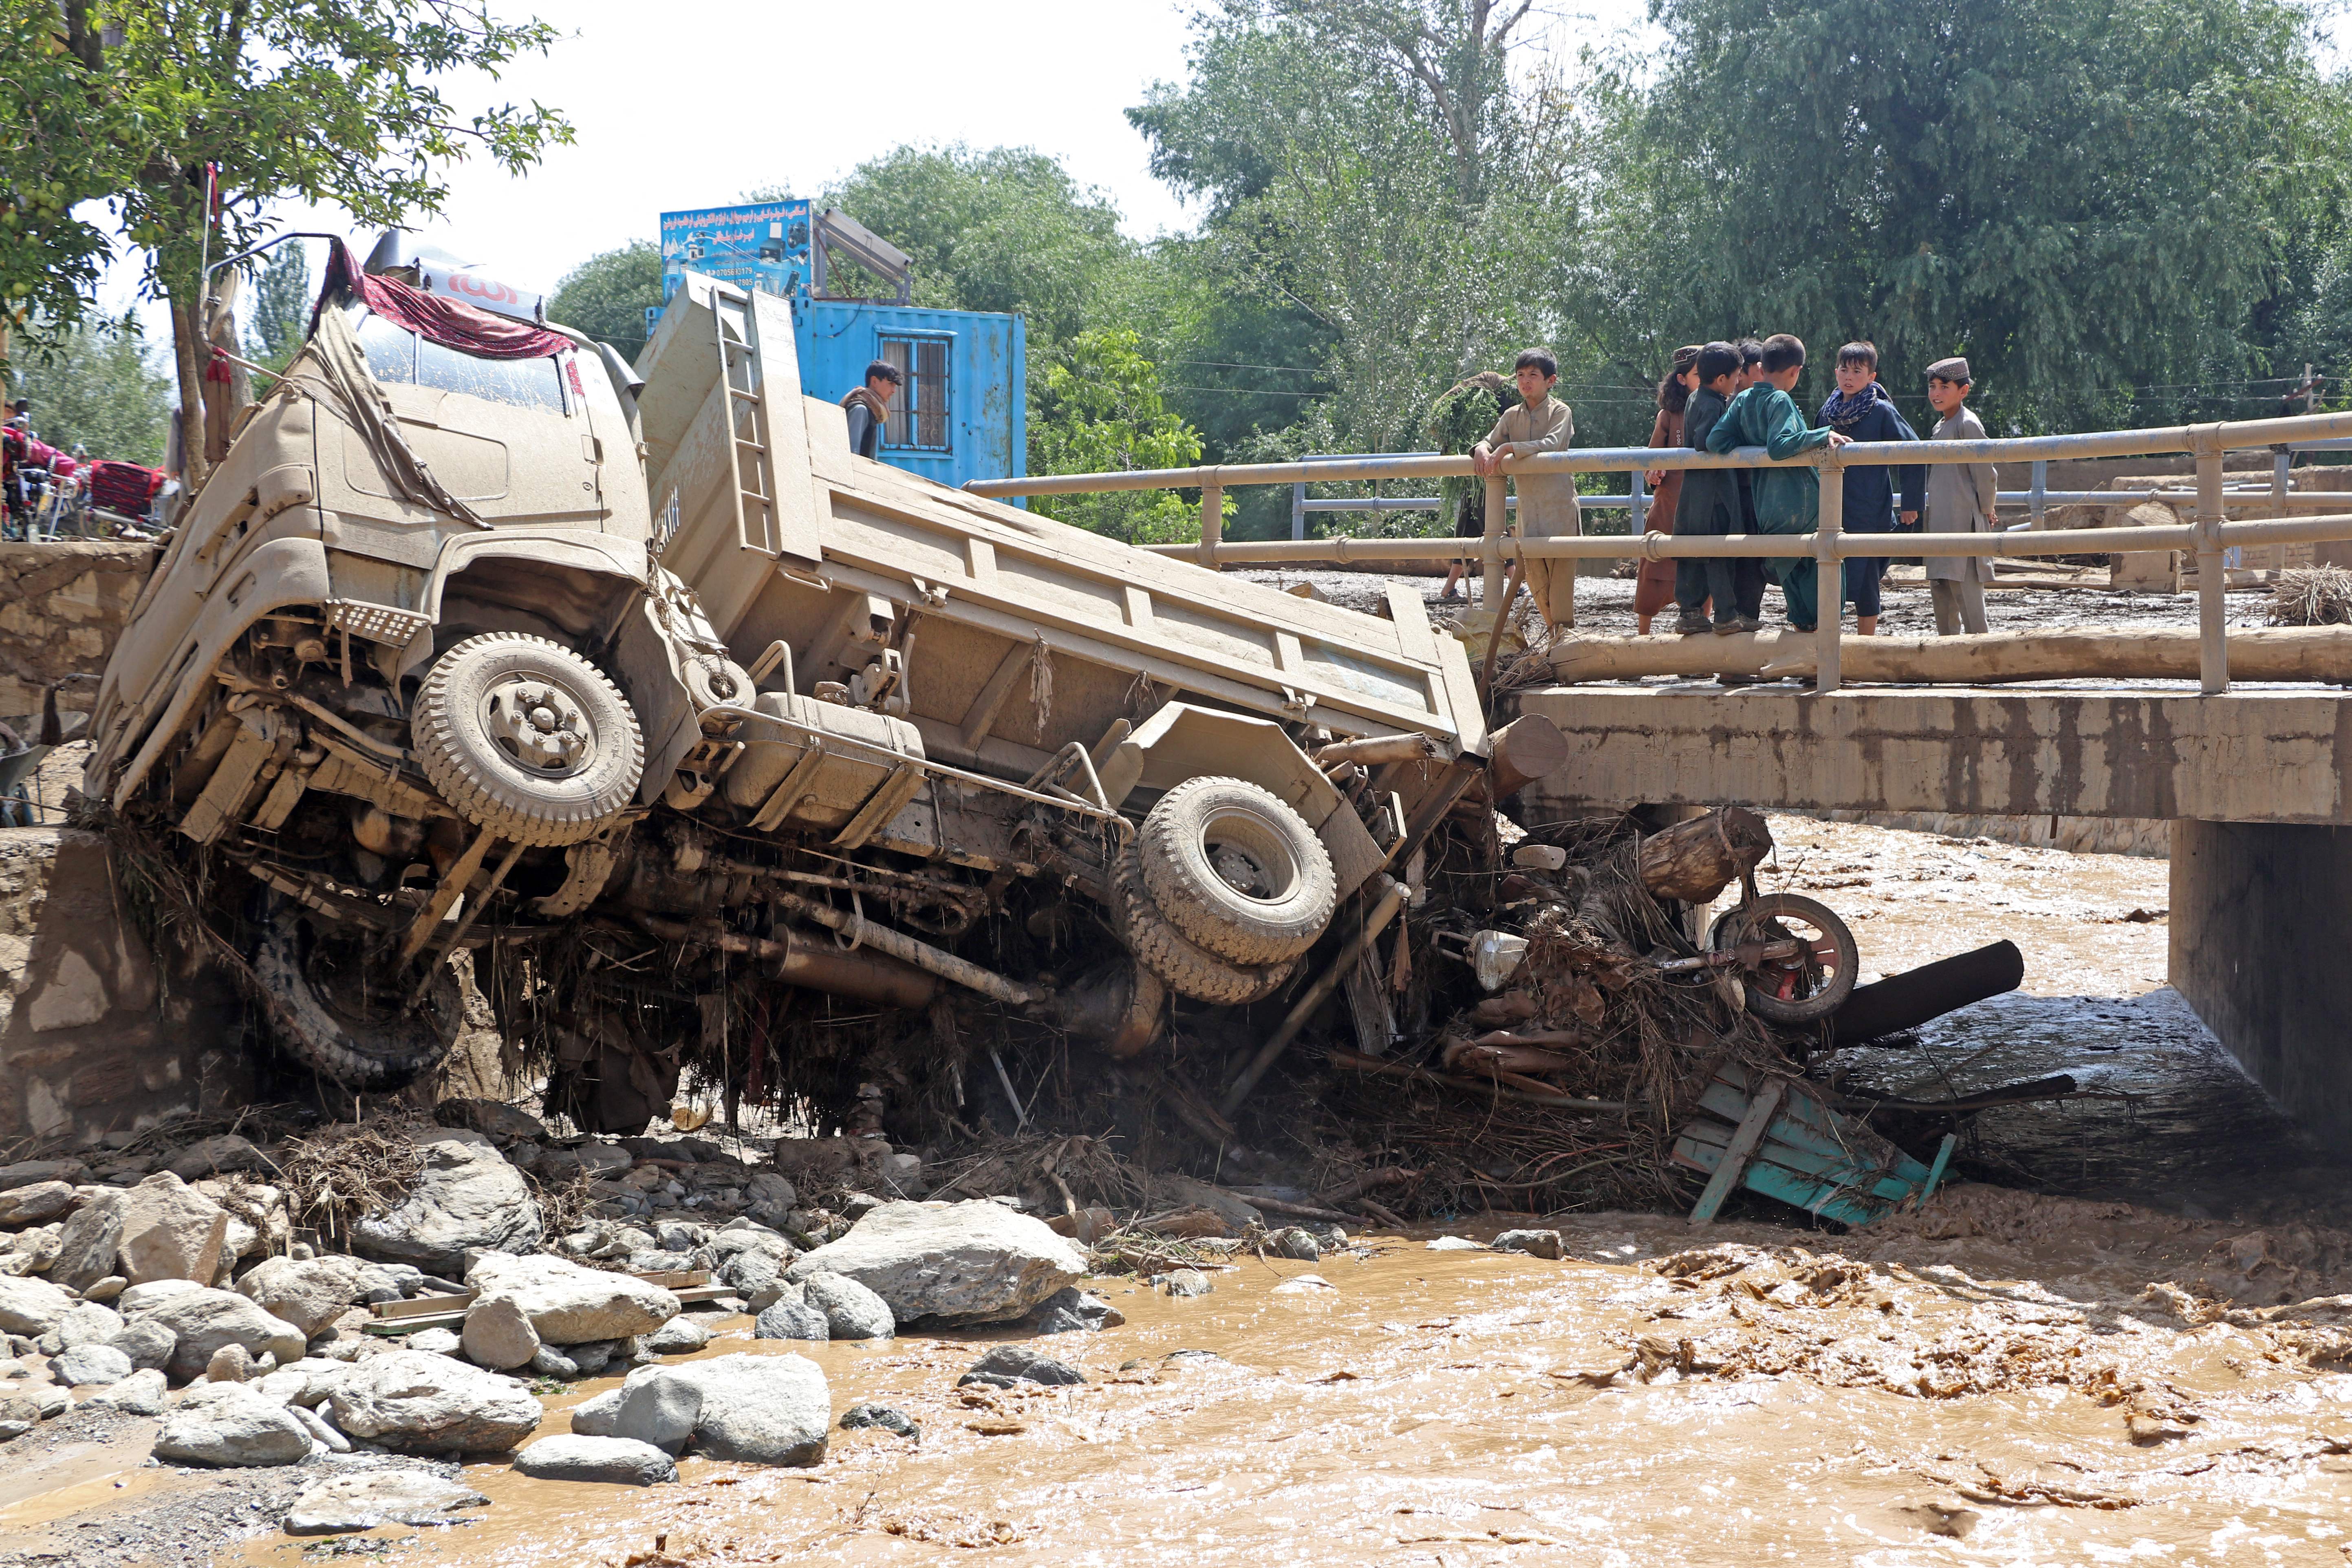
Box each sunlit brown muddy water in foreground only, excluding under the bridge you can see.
[202,1204,2352,1568]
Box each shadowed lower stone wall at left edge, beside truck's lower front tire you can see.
[0,827,251,1142]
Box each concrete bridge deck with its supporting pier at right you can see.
[1517,682,2352,1138]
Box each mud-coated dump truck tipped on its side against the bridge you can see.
[87,247,1541,1131]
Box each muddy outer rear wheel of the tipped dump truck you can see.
[1136,778,1338,966]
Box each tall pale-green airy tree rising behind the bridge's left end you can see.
[1129,0,1559,461]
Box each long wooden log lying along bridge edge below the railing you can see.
[1550,625,2352,686]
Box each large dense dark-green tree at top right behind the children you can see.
[1566,0,2345,428]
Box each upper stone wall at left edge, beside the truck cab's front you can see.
[0,541,158,724]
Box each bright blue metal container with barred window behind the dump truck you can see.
[647,202,1028,484]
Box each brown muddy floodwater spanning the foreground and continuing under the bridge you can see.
[18,816,2352,1568]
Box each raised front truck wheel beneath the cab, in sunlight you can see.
[409,632,644,844]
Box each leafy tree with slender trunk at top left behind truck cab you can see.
[0,0,571,482]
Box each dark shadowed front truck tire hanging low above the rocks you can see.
[254,907,466,1091]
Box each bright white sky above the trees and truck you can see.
[101,0,1644,334]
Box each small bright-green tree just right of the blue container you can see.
[1028,329,1232,545]
